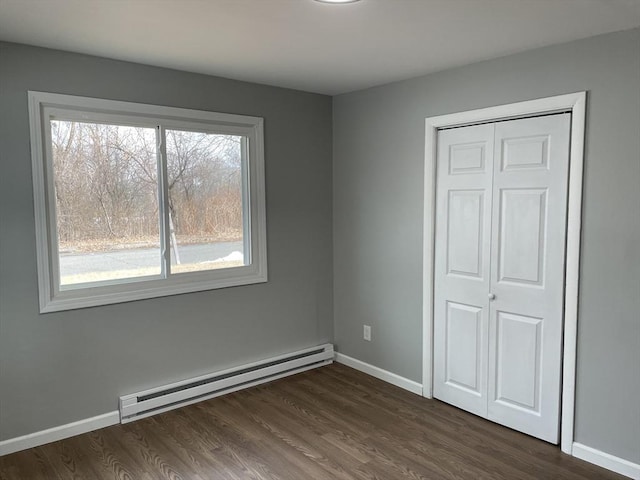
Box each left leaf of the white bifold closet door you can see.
[433,125,495,416]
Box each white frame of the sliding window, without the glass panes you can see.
[28,91,267,313]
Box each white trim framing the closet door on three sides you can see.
[422,92,587,454]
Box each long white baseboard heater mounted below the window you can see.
[120,343,334,423]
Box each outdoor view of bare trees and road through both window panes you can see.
[51,120,245,285]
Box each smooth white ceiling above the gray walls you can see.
[0,0,640,95]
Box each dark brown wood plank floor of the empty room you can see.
[0,364,624,480]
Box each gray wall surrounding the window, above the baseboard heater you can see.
[0,43,333,440]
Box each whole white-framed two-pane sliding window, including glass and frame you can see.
[29,92,267,312]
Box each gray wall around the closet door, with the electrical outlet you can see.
[333,29,640,462]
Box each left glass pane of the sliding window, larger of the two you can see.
[51,120,161,288]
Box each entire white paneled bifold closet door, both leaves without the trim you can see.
[433,114,571,443]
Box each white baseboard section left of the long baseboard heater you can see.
[0,410,120,457]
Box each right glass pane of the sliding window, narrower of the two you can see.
[166,130,246,273]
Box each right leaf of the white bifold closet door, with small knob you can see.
[483,114,571,443]
